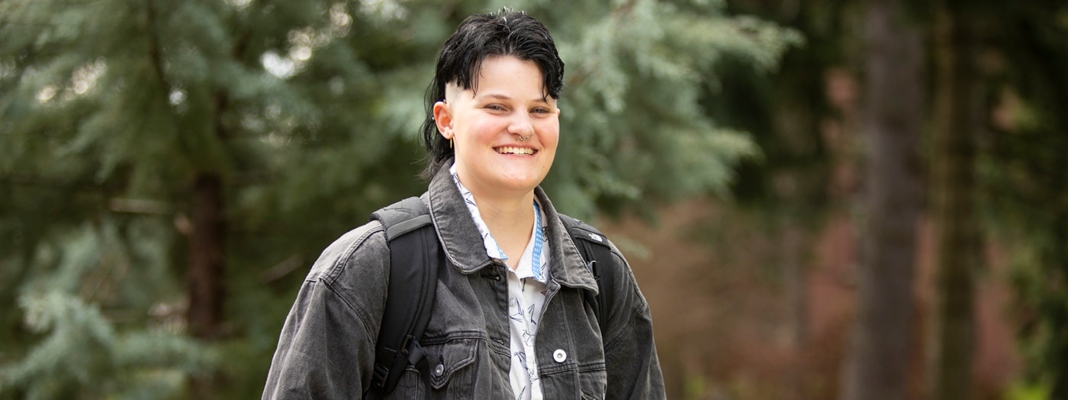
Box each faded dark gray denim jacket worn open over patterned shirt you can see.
[263,165,664,400]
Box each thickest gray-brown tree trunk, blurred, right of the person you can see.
[839,0,924,400]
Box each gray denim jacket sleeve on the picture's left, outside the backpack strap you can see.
[262,223,389,400]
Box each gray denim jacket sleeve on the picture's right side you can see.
[602,250,666,400]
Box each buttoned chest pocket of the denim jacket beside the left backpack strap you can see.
[424,339,478,398]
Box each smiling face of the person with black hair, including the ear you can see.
[434,55,560,196]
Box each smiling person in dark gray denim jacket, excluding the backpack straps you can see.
[263,10,664,400]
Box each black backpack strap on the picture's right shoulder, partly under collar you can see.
[560,214,619,335]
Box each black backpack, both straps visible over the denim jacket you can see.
[365,197,618,399]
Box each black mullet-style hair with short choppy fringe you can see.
[421,9,564,177]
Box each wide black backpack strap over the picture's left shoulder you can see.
[366,197,435,399]
